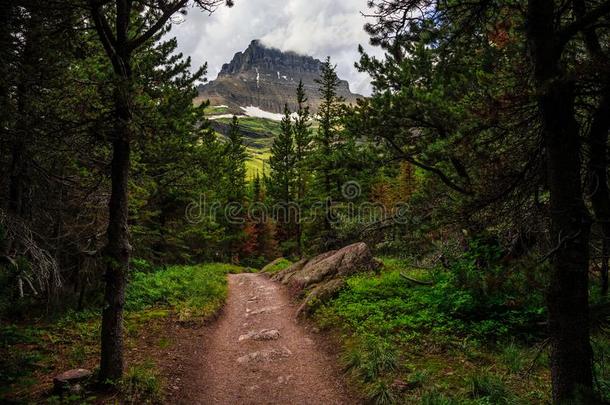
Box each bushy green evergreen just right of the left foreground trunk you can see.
[130,30,224,264]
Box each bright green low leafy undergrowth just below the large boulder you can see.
[319,264,540,340]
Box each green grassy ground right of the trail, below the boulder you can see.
[314,258,550,404]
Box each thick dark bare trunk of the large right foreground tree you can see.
[527,0,593,403]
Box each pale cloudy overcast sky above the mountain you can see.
[171,0,379,95]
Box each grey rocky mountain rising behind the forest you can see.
[198,40,362,113]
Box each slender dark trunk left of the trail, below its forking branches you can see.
[100,64,131,383]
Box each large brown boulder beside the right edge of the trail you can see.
[272,242,381,315]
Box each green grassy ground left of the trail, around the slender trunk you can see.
[0,263,245,403]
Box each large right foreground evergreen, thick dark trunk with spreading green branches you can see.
[361,0,610,403]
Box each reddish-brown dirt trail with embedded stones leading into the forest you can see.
[181,274,354,404]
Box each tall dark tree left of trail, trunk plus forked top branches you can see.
[87,0,232,382]
